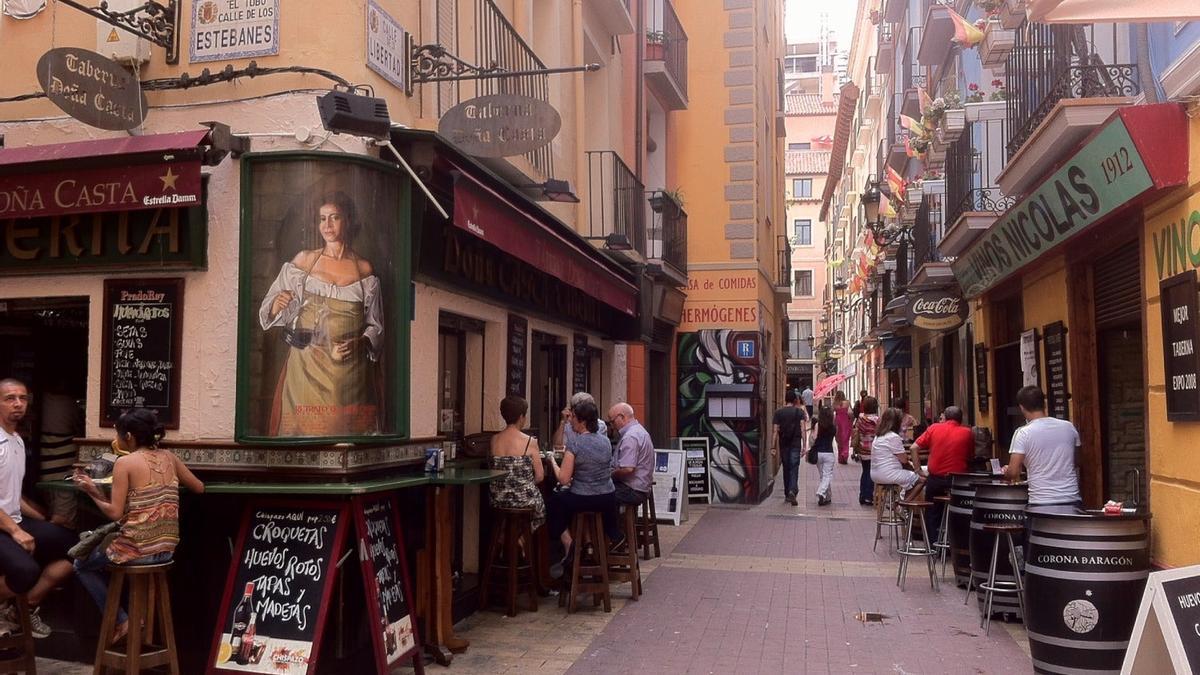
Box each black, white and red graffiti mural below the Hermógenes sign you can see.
[678,330,761,503]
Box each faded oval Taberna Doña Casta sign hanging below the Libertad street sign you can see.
[438,94,563,157]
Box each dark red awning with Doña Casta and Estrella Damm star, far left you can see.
[0,130,209,219]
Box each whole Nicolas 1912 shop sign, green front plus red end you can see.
[952,103,1188,298]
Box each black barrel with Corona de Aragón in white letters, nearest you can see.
[1025,507,1150,673]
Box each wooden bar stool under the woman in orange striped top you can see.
[92,562,179,675]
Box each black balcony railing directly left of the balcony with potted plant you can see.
[587,150,646,256]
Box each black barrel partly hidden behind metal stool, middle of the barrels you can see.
[970,480,1028,617]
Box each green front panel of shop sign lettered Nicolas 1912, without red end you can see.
[953,118,1154,298]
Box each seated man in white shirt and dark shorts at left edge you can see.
[0,378,78,638]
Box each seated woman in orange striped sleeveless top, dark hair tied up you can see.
[74,408,204,643]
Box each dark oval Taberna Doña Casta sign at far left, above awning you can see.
[37,47,146,131]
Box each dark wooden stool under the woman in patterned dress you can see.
[479,508,540,616]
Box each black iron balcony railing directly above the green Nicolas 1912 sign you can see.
[1006,23,1141,157]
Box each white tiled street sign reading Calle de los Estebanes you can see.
[191,0,280,64]
